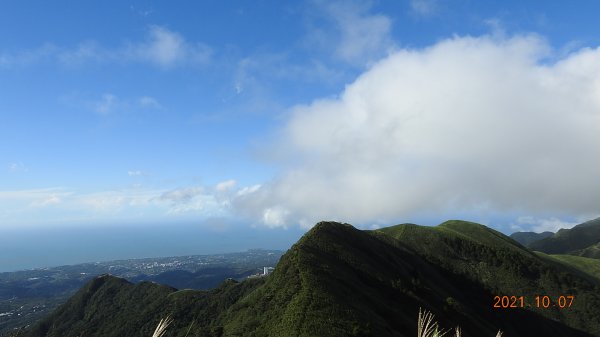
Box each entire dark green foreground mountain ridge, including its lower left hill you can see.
[16,221,600,337]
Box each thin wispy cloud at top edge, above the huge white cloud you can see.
[309,1,395,66]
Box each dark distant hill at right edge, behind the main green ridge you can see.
[528,218,600,259]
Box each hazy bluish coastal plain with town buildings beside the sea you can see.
[0,250,282,336]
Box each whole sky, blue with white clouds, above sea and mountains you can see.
[0,0,600,268]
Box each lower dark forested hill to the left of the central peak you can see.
[27,275,263,337]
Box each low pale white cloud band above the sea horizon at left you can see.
[0,181,248,228]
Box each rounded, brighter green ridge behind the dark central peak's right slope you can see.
[382,221,600,334]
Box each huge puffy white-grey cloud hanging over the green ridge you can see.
[234,35,600,225]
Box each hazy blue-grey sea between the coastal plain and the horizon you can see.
[0,224,303,272]
